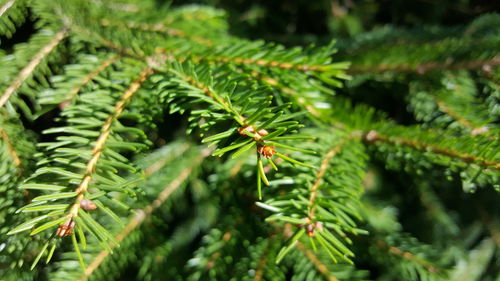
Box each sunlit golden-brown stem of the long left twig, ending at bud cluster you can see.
[67,67,153,221]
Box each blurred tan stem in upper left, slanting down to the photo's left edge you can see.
[0,28,68,107]
